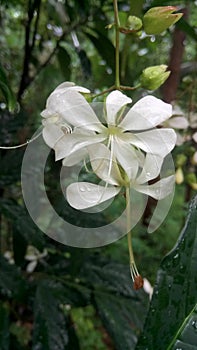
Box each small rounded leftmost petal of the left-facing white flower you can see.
[42,124,64,148]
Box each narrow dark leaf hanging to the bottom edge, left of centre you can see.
[32,280,68,350]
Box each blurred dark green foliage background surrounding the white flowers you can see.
[0,0,197,350]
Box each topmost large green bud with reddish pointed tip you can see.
[143,6,183,34]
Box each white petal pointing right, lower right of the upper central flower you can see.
[126,129,176,157]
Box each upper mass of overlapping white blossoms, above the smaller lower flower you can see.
[41,83,176,168]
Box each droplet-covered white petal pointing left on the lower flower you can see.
[66,182,120,210]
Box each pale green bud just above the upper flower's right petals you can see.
[140,64,170,90]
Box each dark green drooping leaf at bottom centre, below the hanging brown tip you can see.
[81,263,148,350]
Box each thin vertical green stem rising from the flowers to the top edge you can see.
[113,0,120,90]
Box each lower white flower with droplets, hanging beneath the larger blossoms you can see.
[66,144,174,210]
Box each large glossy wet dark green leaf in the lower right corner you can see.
[136,196,197,350]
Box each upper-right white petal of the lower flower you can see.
[137,153,163,184]
